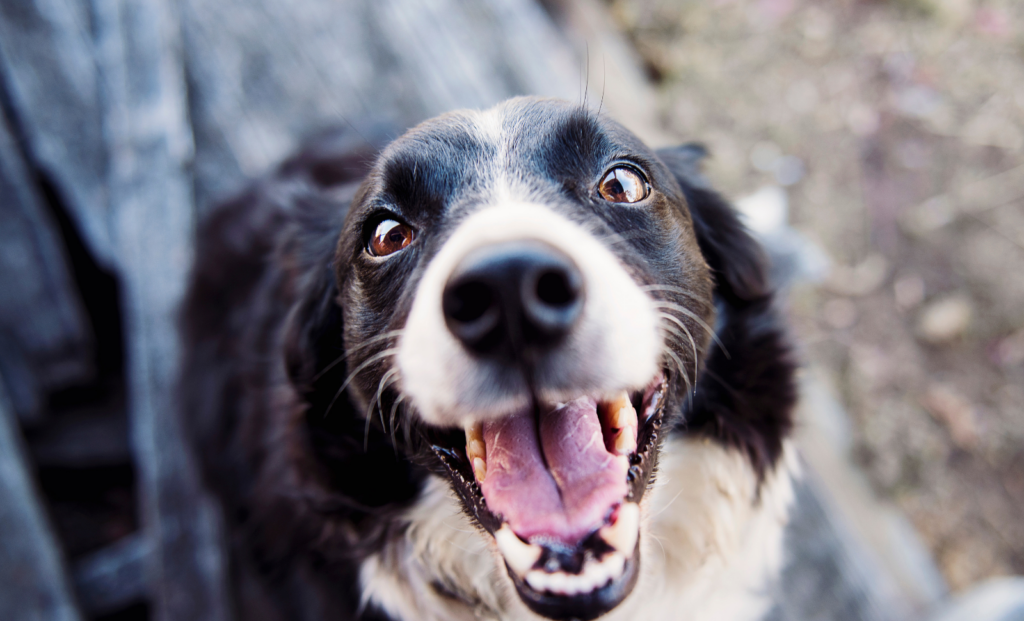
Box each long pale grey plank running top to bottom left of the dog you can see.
[94,0,230,621]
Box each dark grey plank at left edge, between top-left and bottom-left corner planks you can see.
[0,99,93,422]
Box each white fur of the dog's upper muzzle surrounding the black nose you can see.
[397,202,662,425]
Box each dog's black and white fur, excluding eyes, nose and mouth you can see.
[181,98,796,621]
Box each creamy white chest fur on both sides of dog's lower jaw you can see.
[360,439,799,621]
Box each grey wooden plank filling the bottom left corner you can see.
[0,378,81,621]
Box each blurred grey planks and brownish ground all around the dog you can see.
[0,0,1024,621]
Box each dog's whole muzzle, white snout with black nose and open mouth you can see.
[397,203,666,619]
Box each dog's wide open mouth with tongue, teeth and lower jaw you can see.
[433,374,667,619]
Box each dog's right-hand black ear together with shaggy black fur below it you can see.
[658,144,797,480]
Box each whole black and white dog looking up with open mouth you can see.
[180,97,798,621]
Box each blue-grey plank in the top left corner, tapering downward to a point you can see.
[0,0,114,267]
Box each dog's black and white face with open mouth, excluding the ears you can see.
[336,99,714,619]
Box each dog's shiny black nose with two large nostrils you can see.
[442,242,584,354]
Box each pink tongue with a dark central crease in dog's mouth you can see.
[480,397,629,545]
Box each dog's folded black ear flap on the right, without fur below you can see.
[657,144,769,301]
